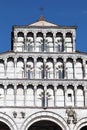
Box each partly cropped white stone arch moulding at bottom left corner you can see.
[0,113,18,130]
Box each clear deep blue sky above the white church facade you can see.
[0,0,87,53]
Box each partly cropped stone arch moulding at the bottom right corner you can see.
[74,117,87,130]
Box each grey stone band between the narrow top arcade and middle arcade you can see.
[0,52,87,61]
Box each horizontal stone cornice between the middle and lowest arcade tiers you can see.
[0,79,87,86]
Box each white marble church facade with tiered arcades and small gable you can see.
[0,17,87,130]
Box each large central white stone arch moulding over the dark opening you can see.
[21,111,70,130]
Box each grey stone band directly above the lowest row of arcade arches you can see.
[0,79,87,86]
